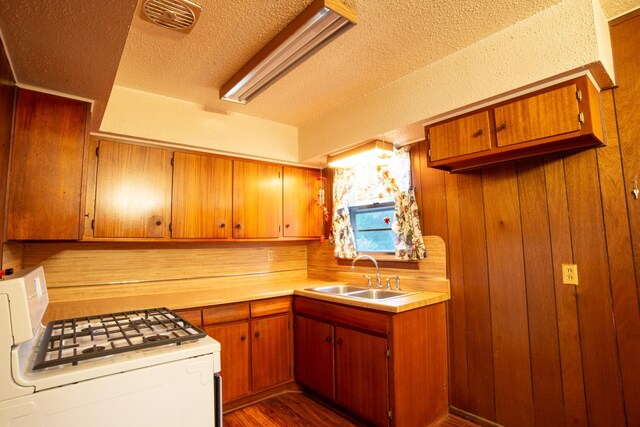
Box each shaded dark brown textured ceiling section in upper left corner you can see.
[0,0,137,128]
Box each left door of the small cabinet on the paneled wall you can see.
[429,111,491,162]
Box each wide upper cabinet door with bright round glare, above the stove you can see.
[93,141,171,238]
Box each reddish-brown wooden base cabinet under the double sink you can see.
[294,297,449,427]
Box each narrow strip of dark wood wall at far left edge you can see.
[0,40,16,262]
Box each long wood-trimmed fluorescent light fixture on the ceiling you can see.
[220,0,357,104]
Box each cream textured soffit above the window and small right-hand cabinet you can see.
[299,0,613,161]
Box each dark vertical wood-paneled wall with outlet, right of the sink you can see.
[412,13,640,427]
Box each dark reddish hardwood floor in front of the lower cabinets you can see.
[223,392,476,427]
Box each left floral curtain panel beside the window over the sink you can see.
[332,169,356,258]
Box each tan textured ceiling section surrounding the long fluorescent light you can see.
[116,0,558,125]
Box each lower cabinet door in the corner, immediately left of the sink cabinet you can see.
[251,314,291,391]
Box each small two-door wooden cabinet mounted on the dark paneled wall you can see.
[425,76,604,172]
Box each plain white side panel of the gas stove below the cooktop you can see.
[0,354,216,427]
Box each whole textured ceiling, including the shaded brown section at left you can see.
[0,0,639,130]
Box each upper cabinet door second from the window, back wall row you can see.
[233,160,282,239]
